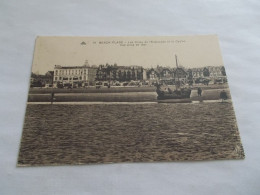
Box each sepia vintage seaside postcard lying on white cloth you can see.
[18,35,244,166]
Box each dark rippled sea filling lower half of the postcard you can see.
[18,103,244,166]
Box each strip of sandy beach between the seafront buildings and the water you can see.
[28,85,231,102]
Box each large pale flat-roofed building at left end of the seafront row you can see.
[53,65,97,87]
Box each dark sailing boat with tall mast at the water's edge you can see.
[156,55,191,101]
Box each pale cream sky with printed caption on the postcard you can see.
[32,35,223,74]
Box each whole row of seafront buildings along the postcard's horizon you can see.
[49,64,226,87]
